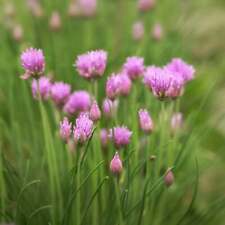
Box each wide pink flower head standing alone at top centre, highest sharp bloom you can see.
[75,50,107,79]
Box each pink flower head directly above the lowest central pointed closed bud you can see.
[109,126,132,148]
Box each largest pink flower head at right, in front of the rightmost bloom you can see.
[144,66,184,99]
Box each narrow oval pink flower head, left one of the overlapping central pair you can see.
[106,74,121,100]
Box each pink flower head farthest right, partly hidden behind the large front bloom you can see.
[165,58,195,83]
